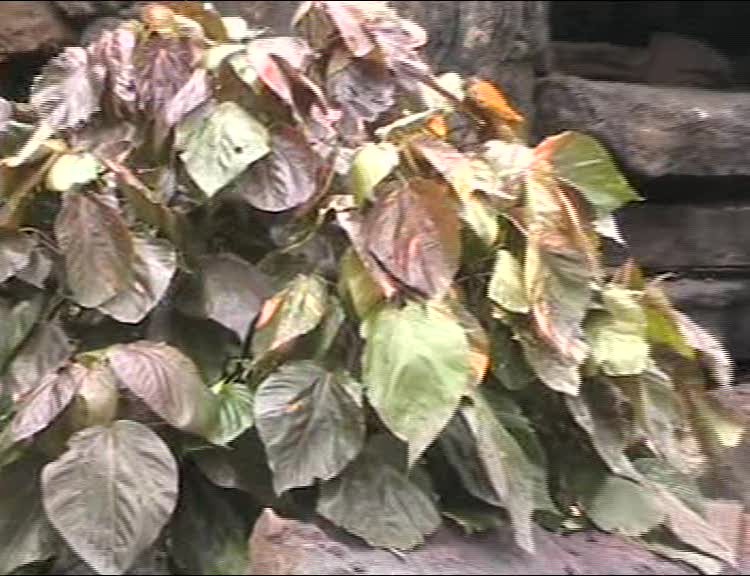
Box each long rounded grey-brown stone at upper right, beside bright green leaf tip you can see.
[536,76,750,178]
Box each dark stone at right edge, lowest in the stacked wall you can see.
[665,278,750,362]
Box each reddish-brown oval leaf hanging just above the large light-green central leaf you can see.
[365,179,461,296]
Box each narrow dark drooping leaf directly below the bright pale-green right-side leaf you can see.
[565,381,640,481]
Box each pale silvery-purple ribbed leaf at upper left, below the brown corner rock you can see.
[29,47,105,131]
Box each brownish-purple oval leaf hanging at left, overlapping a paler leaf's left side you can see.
[55,193,134,308]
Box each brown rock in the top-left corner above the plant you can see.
[0,2,76,62]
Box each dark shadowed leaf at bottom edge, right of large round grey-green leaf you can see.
[170,471,251,576]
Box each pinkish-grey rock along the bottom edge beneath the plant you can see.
[249,509,696,574]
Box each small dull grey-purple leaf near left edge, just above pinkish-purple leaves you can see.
[6,320,73,398]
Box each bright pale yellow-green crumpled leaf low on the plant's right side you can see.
[586,286,650,376]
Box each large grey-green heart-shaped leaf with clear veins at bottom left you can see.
[42,420,177,574]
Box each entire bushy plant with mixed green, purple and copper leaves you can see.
[0,2,744,574]
